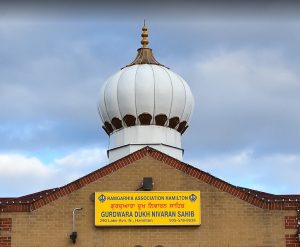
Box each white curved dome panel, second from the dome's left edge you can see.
[104,70,123,120]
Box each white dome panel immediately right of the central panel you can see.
[152,65,172,117]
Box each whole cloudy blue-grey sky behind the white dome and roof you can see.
[0,1,300,197]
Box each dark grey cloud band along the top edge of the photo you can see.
[0,0,299,21]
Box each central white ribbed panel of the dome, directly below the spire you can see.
[135,64,154,115]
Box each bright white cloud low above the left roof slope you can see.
[0,148,107,197]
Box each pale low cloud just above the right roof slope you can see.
[191,149,300,194]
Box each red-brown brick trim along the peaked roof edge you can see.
[0,147,300,212]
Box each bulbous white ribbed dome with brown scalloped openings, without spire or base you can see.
[98,64,194,134]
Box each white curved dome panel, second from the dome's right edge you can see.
[166,70,186,118]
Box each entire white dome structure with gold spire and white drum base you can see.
[98,23,194,162]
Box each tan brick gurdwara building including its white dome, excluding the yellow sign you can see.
[0,23,300,247]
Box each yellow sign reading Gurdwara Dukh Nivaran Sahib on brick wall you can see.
[95,191,201,226]
